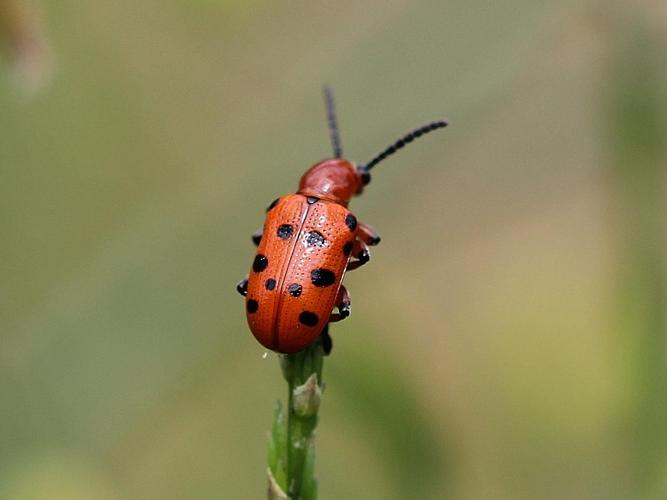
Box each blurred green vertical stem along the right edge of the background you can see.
[606,7,667,498]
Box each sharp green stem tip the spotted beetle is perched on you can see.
[269,340,324,500]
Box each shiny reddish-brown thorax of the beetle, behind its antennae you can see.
[298,159,363,206]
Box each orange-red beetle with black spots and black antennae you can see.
[236,86,447,354]
